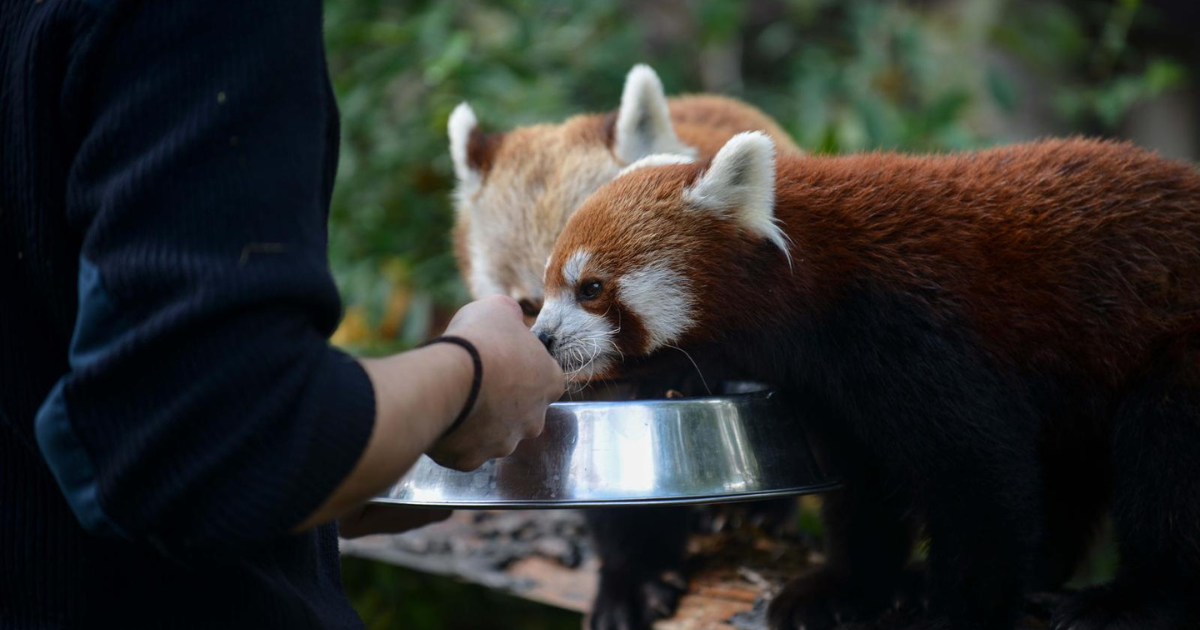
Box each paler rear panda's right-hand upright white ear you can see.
[613,64,696,164]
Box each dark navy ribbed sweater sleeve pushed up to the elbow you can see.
[36,0,374,547]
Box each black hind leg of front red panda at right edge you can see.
[1055,337,1200,630]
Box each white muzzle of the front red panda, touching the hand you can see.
[533,292,619,380]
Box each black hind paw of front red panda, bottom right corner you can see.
[1050,582,1200,630]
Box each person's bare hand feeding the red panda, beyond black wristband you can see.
[428,295,565,470]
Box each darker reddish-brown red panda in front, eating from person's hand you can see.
[534,133,1200,630]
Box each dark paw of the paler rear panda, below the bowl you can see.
[587,570,688,630]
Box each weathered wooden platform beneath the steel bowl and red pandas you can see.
[342,510,1052,630]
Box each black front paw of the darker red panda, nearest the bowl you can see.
[767,569,892,630]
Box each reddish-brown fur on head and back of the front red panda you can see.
[547,139,1200,385]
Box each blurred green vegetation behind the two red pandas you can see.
[325,0,1200,628]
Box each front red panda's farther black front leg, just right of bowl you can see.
[767,439,913,630]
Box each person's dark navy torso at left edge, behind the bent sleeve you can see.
[0,0,361,630]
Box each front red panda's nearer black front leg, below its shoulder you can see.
[842,336,1043,630]
